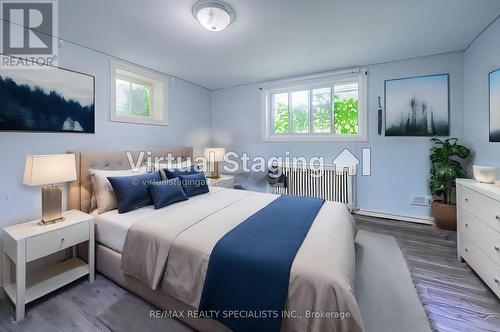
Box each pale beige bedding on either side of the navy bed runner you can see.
[114,188,363,332]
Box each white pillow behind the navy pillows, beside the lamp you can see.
[89,167,146,213]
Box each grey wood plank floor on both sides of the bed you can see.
[0,216,500,332]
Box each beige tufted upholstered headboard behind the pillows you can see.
[68,146,193,213]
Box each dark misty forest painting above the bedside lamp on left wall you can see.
[0,60,95,133]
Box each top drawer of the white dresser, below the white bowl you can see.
[457,185,500,232]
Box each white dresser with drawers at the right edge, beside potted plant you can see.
[457,179,500,297]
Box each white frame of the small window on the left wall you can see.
[110,60,168,126]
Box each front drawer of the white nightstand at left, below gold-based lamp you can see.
[26,221,90,262]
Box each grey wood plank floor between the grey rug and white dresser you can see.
[355,215,500,332]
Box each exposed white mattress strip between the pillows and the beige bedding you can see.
[93,187,224,253]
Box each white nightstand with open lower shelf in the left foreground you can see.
[3,210,94,321]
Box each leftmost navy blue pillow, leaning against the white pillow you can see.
[108,172,161,213]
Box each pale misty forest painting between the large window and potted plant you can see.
[384,74,450,136]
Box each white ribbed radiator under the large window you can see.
[268,165,356,210]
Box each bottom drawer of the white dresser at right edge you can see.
[460,235,500,297]
